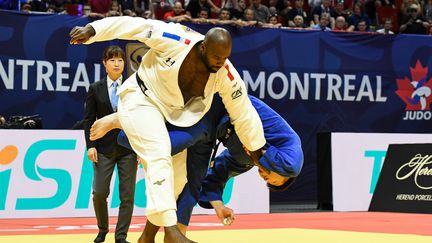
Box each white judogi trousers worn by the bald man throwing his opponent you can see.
[118,75,187,226]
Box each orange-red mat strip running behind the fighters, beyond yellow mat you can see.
[0,212,432,236]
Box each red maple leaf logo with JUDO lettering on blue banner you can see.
[396,60,432,120]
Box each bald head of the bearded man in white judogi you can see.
[200,27,232,72]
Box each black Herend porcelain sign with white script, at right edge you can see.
[369,144,432,213]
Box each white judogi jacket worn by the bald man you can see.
[85,17,265,151]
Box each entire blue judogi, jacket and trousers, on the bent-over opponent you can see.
[118,95,303,225]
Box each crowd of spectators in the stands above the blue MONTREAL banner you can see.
[0,0,432,34]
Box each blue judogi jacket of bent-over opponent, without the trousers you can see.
[199,96,303,208]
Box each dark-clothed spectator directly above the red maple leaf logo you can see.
[399,4,429,35]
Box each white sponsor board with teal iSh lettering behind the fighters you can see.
[0,130,269,218]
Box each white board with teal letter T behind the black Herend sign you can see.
[331,133,432,211]
